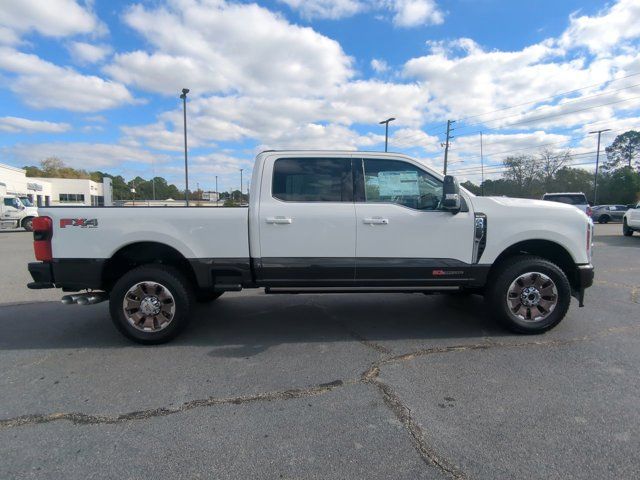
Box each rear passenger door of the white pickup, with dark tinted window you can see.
[256,156,356,286]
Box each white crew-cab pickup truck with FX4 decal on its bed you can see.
[29,151,593,343]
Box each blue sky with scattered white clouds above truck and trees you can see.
[0,0,640,189]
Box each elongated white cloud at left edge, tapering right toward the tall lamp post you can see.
[0,47,134,112]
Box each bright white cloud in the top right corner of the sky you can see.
[559,0,640,54]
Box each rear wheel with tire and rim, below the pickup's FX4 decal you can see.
[109,265,194,345]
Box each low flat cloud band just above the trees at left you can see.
[4,142,168,170]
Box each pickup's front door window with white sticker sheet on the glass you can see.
[364,159,442,210]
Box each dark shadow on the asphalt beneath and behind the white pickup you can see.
[0,292,508,350]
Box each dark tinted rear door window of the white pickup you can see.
[272,158,353,202]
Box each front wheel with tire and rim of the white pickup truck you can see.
[487,255,571,334]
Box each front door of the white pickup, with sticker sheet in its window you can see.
[354,158,474,286]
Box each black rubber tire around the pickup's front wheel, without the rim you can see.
[490,257,571,334]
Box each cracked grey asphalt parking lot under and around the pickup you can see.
[0,224,640,479]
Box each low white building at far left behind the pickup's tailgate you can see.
[0,163,112,206]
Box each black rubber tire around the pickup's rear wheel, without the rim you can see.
[109,265,193,345]
